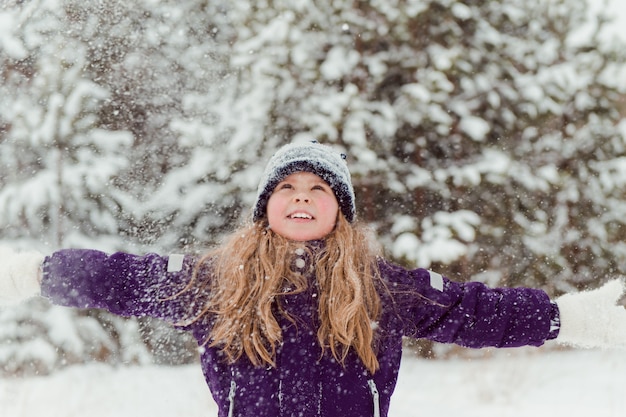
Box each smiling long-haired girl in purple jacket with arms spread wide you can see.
[0,143,626,417]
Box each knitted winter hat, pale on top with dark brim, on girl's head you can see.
[253,142,356,222]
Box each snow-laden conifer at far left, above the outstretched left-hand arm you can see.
[0,2,132,248]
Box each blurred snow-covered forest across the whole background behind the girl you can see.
[0,0,626,374]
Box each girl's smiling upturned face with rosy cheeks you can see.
[267,172,339,242]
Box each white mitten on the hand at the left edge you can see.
[0,246,44,305]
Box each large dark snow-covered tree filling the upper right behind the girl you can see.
[172,0,624,290]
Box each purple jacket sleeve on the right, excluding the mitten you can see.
[380,263,559,348]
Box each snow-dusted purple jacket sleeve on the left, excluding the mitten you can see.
[41,249,202,323]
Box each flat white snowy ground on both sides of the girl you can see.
[0,349,626,417]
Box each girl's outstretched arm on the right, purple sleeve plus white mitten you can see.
[381,264,626,349]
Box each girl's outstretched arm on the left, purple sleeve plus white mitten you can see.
[0,248,201,323]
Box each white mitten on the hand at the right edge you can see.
[555,280,626,348]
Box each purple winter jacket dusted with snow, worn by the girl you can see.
[42,249,559,417]
